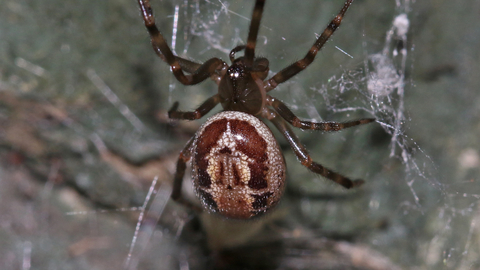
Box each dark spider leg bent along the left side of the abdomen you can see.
[170,137,202,212]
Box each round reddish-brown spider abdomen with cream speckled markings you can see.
[192,111,285,219]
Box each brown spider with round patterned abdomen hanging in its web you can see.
[138,0,375,219]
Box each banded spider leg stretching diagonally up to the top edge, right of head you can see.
[263,0,353,92]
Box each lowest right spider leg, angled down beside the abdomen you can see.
[262,110,364,188]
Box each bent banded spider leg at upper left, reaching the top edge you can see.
[138,0,227,85]
